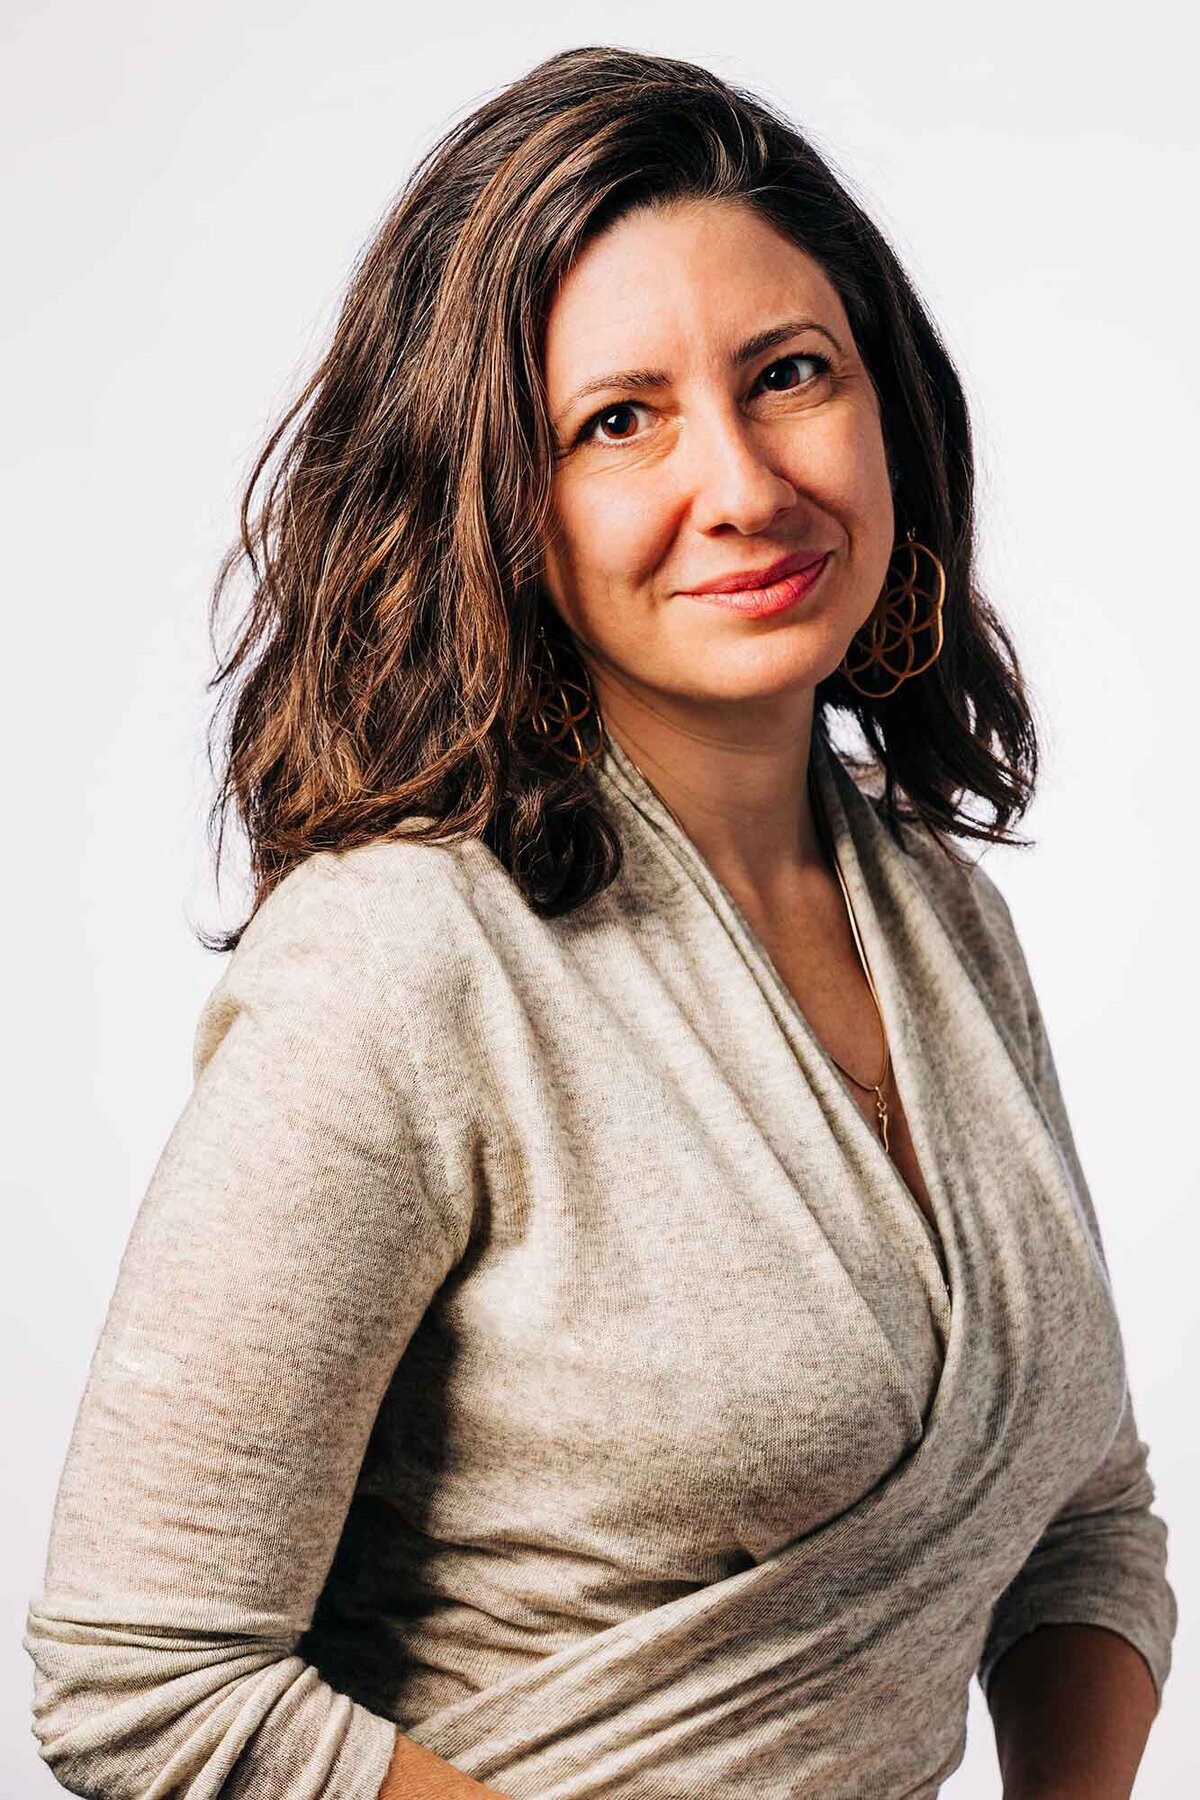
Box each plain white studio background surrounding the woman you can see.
[0,0,1200,1800]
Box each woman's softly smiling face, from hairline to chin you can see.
[543,202,894,731]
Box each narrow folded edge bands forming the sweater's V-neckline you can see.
[599,725,955,1317]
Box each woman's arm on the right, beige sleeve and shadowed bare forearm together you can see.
[977,869,1178,1800]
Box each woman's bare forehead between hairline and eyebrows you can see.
[543,200,851,394]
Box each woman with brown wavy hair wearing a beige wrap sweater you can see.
[25,49,1177,1800]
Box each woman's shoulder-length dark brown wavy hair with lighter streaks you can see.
[200,47,1038,950]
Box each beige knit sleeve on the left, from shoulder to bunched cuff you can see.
[23,853,466,1800]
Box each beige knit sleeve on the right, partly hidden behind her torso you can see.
[975,871,1178,1701]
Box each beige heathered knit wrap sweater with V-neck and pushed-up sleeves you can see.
[25,733,1177,1800]
